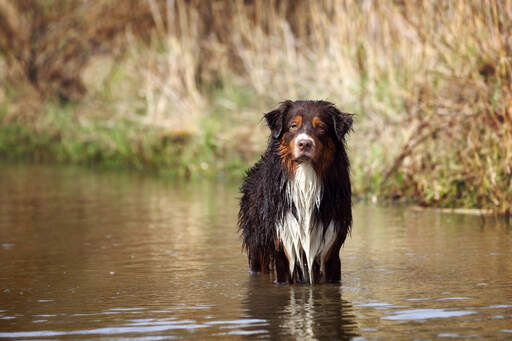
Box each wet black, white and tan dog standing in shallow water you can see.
[238,100,353,284]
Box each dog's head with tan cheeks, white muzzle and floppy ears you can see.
[265,101,352,175]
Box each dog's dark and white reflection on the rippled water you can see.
[246,276,358,340]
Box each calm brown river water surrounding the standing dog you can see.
[0,165,512,340]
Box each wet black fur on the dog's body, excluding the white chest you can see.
[238,101,352,282]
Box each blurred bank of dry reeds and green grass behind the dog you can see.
[0,0,512,215]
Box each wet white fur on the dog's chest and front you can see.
[277,162,336,283]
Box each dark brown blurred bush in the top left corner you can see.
[0,0,154,100]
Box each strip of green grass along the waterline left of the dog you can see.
[0,97,254,178]
